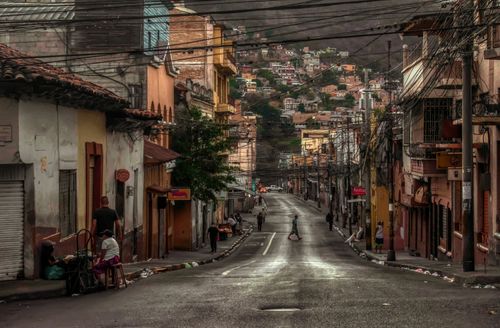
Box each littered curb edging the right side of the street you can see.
[296,196,500,287]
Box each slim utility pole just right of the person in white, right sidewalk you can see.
[386,40,396,261]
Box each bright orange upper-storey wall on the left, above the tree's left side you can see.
[147,65,175,148]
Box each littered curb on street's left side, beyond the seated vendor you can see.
[125,226,253,281]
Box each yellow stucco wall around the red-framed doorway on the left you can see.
[76,110,106,229]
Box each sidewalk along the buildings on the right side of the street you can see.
[298,198,500,288]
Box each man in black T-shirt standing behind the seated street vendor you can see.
[90,196,122,246]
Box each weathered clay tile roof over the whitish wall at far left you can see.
[0,43,128,110]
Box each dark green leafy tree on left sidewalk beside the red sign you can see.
[172,108,235,201]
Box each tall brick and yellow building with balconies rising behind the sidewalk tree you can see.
[170,3,237,249]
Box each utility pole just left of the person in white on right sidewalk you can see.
[361,69,372,251]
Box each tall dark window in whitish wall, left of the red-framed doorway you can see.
[59,170,76,237]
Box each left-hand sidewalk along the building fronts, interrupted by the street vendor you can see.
[0,213,255,303]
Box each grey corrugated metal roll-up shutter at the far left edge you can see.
[0,181,24,280]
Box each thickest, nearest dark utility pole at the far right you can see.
[462,0,475,272]
